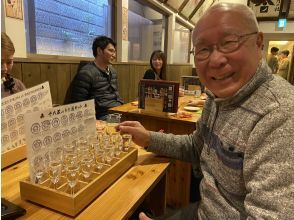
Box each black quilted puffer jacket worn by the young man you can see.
[71,62,123,119]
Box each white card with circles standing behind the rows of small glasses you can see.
[24,99,96,182]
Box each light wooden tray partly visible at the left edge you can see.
[1,145,27,169]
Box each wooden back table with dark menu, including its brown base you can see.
[110,96,202,208]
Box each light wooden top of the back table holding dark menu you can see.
[110,96,202,124]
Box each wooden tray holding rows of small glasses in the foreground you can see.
[20,147,138,216]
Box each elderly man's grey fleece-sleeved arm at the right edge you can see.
[243,108,294,219]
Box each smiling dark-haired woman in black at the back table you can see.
[143,50,166,80]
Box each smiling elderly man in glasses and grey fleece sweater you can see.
[118,3,294,220]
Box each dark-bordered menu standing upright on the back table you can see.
[138,79,179,112]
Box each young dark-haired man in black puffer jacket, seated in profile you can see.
[71,36,123,120]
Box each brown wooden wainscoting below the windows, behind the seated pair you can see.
[13,60,192,104]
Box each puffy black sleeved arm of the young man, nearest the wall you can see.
[71,69,93,102]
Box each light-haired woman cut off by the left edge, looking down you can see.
[1,32,26,98]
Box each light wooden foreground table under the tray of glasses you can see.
[1,148,170,220]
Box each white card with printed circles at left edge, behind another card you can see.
[1,82,52,153]
